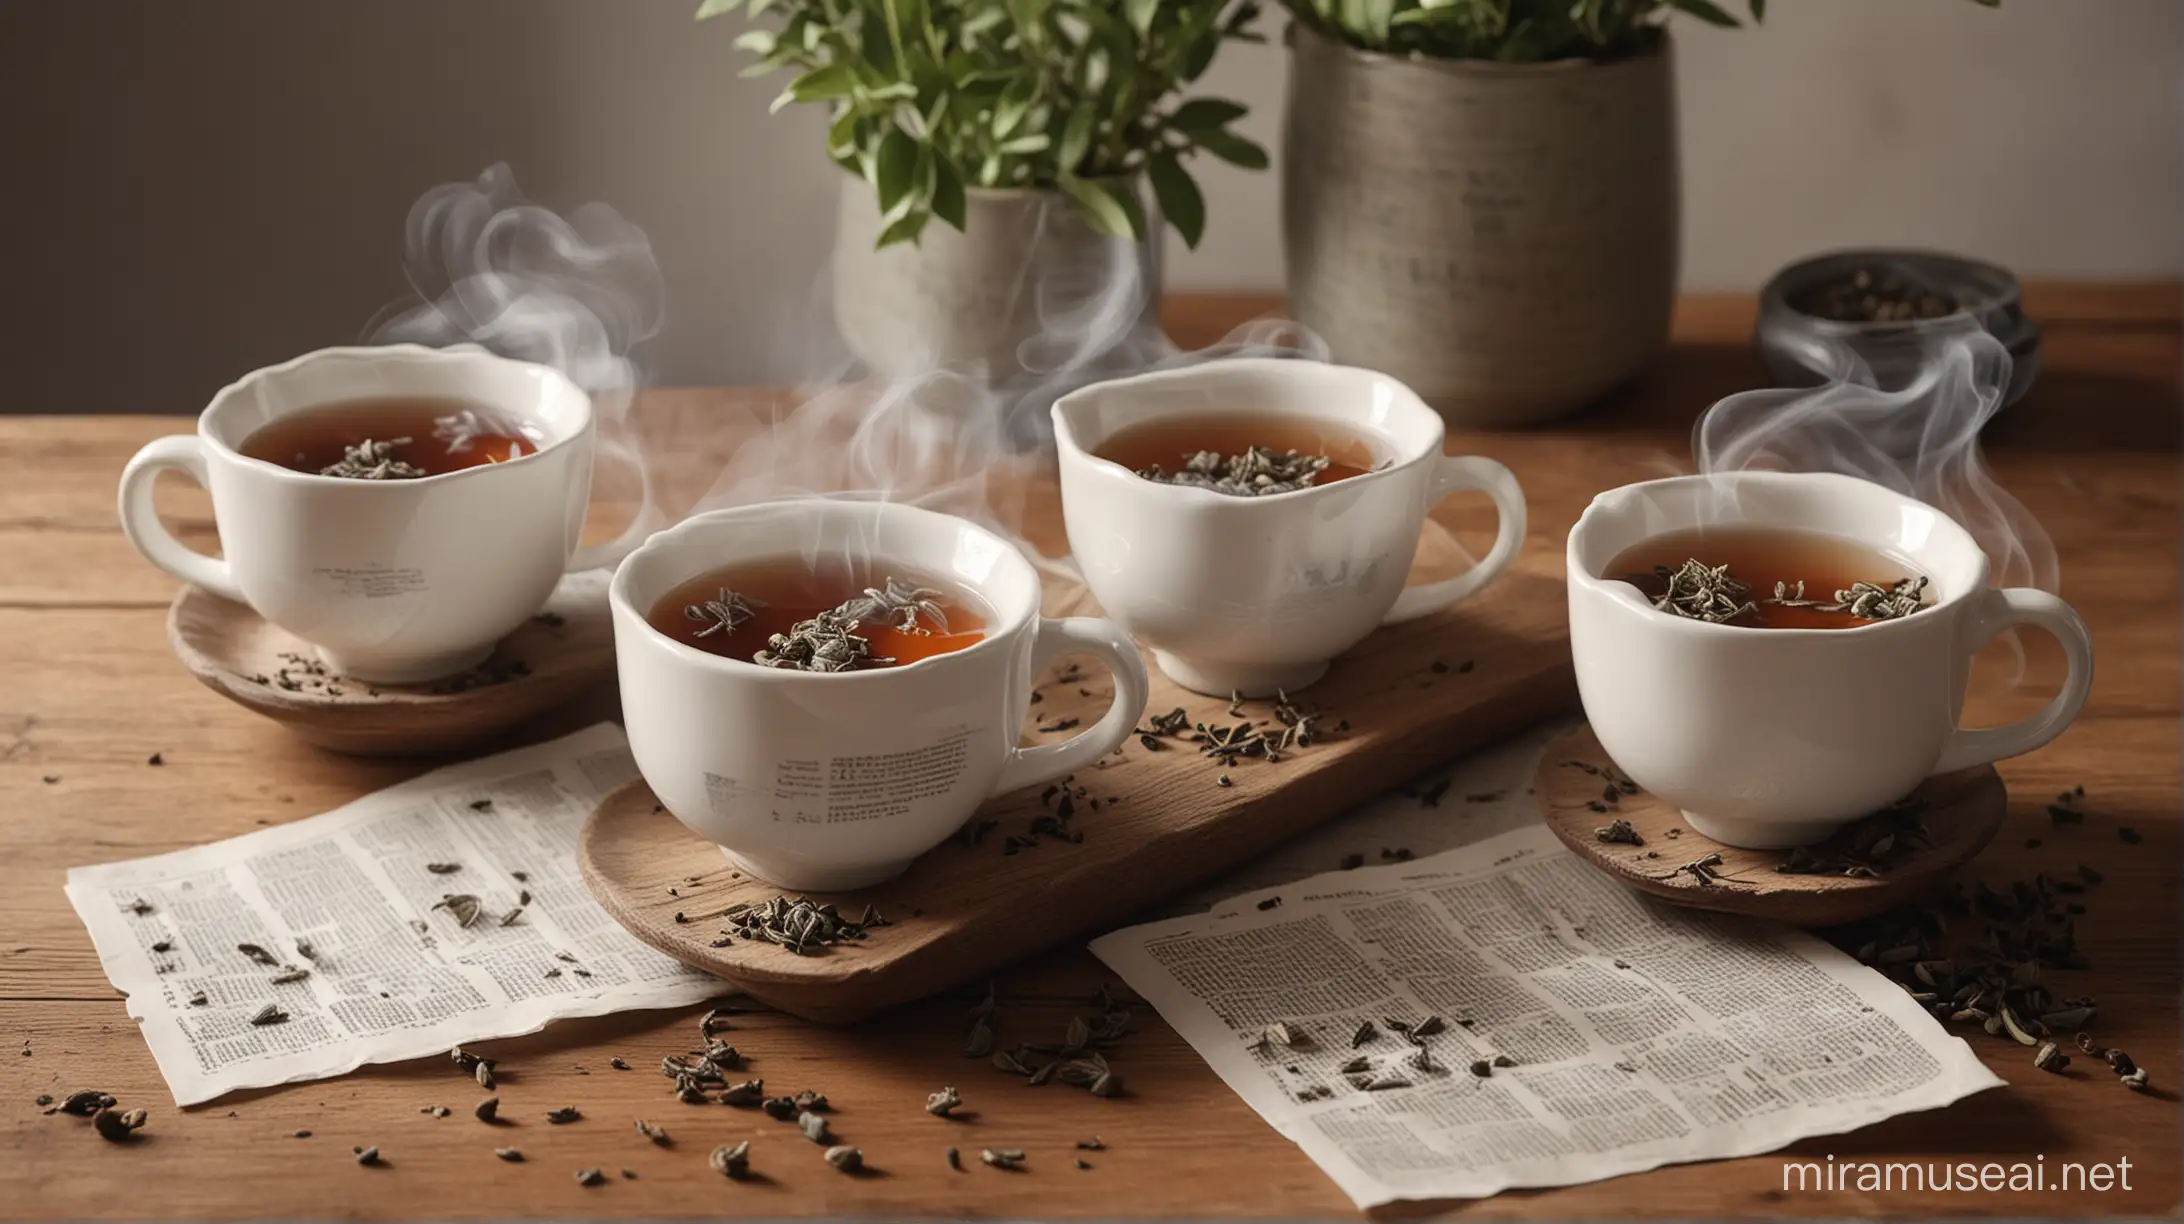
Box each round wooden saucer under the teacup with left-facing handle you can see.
[166,570,614,756]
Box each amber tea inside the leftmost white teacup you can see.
[242,396,544,476]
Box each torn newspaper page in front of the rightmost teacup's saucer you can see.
[1092,822,2001,1209]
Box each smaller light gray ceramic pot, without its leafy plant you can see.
[834,177,1160,385]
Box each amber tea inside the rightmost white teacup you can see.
[1601,527,1931,629]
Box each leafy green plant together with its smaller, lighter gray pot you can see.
[697,0,1267,378]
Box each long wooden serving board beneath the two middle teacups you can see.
[577,566,1577,1021]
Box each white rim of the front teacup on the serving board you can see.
[607,496,1044,684]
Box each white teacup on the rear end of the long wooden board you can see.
[1053,358,1524,697]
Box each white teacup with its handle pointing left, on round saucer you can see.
[120,345,633,684]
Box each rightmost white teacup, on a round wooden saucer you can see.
[1568,472,2092,848]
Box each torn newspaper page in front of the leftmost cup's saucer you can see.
[68,723,727,1106]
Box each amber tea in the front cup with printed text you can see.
[644,557,992,671]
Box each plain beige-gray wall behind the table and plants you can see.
[0,0,2184,411]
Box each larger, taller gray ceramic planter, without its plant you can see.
[1282,24,1677,424]
